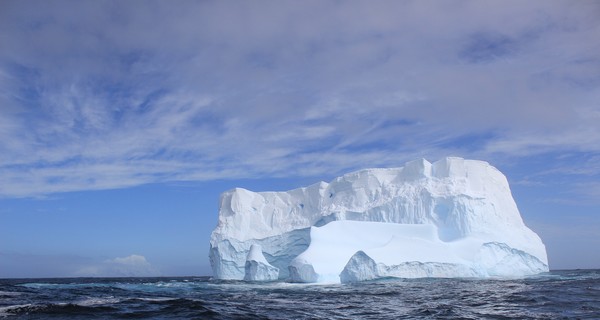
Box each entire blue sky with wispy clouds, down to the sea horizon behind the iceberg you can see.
[0,0,600,278]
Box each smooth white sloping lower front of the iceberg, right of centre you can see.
[290,221,547,283]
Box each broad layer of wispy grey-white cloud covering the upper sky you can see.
[0,1,600,197]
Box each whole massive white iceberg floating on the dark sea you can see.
[210,158,548,282]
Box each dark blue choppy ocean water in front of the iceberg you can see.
[0,270,600,319]
